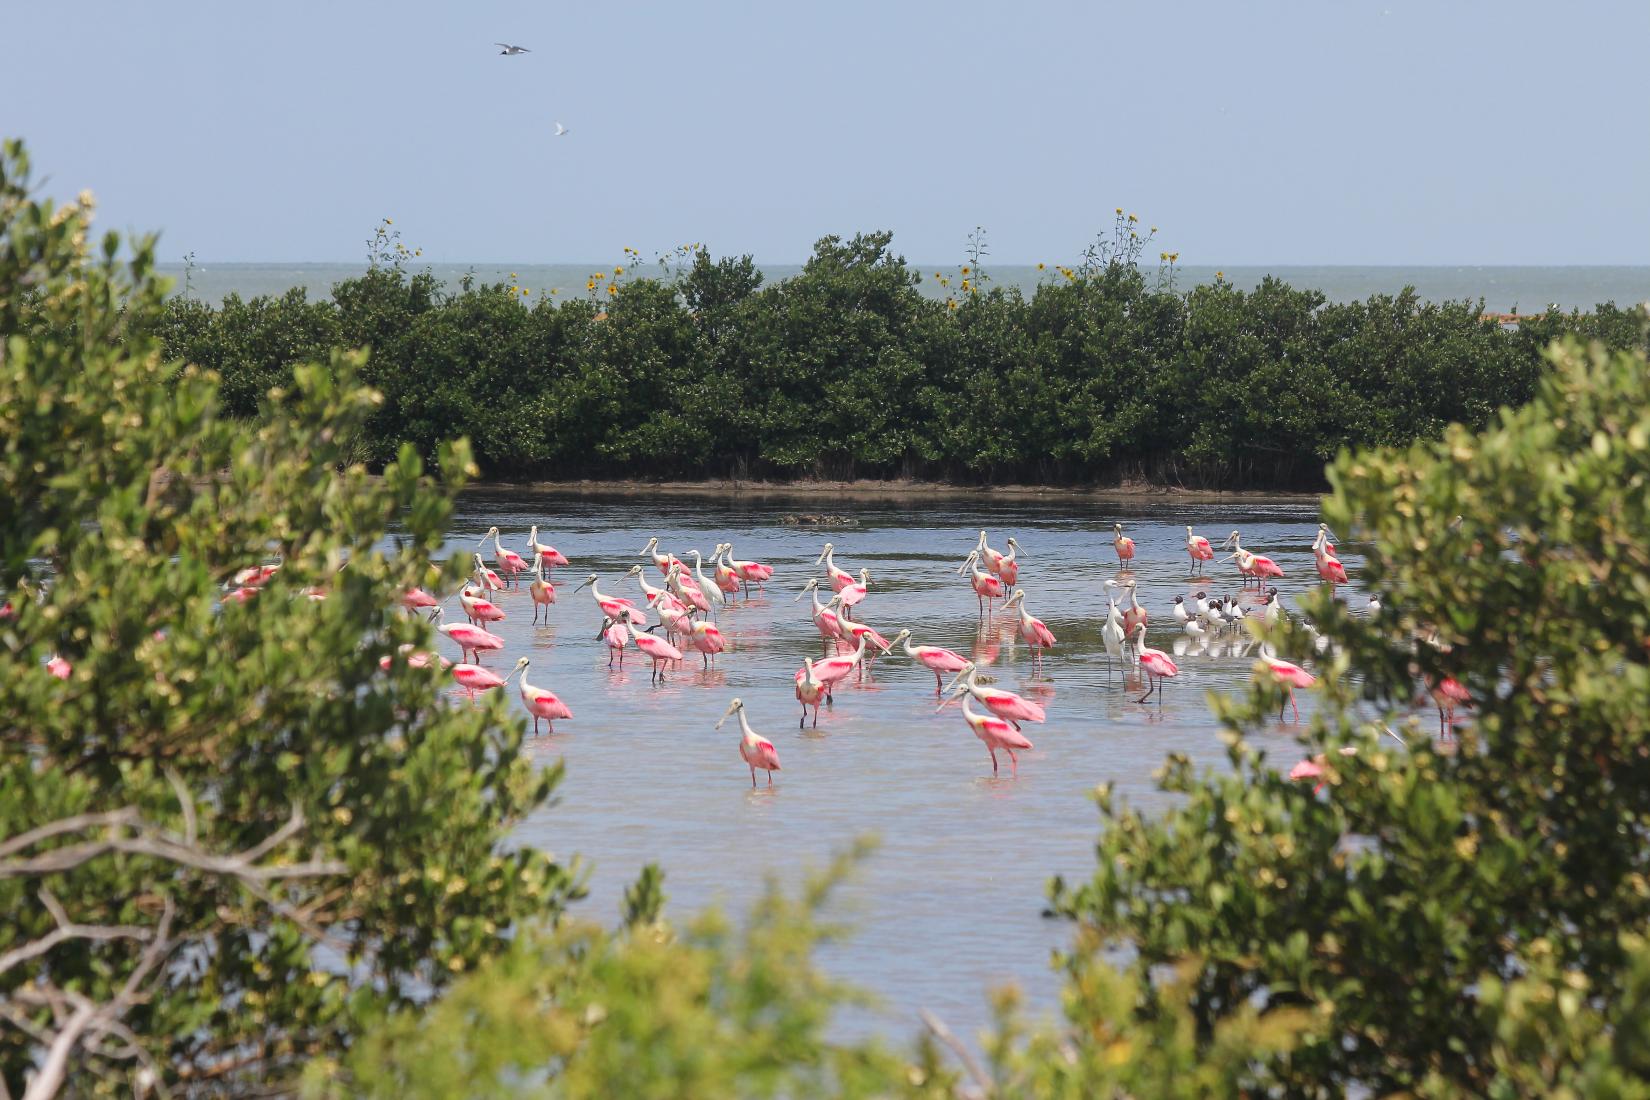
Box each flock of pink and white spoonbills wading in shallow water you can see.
[29,523,1472,787]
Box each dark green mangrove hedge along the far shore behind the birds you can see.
[155,226,1642,488]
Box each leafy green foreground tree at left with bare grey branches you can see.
[0,143,574,1097]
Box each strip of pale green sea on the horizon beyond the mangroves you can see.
[148,262,1650,313]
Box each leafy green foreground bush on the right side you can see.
[1054,333,1650,1095]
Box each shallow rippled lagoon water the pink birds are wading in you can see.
[422,490,1363,1037]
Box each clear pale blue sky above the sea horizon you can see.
[0,0,1650,264]
